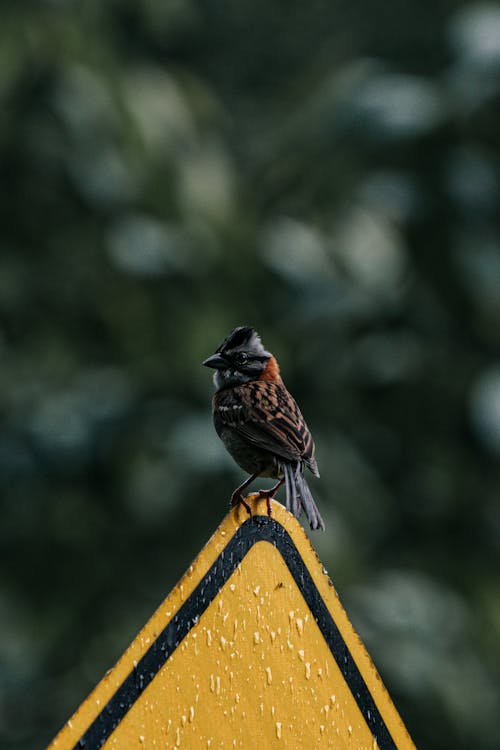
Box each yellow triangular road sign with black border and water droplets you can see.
[49,495,414,750]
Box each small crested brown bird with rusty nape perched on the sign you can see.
[203,326,325,530]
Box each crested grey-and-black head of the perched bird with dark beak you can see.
[203,326,279,390]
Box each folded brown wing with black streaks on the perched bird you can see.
[214,381,314,465]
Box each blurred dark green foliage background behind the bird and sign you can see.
[0,0,500,750]
